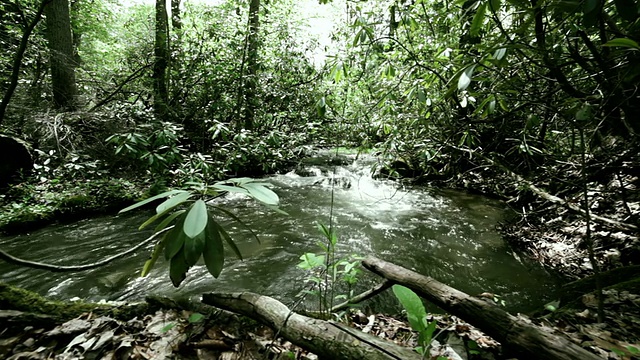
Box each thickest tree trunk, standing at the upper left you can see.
[44,0,77,110]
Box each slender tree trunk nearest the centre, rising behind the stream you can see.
[244,0,260,130]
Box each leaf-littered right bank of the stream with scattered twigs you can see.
[449,149,640,359]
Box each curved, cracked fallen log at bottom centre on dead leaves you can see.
[202,292,420,360]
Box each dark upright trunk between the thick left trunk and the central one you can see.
[153,0,169,119]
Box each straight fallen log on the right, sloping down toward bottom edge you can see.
[362,257,601,360]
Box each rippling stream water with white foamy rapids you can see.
[0,153,555,311]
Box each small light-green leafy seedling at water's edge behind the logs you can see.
[298,223,362,317]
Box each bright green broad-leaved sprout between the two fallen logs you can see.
[393,285,436,356]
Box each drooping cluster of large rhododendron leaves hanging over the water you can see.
[120,178,279,287]
